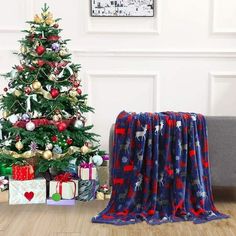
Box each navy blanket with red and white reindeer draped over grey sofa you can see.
[92,111,228,225]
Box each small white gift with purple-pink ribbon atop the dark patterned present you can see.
[78,163,97,180]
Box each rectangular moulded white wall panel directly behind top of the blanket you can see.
[87,72,160,149]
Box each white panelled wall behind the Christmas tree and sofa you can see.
[0,0,236,149]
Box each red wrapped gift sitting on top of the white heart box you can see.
[12,165,34,180]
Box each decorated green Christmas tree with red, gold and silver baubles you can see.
[0,4,102,173]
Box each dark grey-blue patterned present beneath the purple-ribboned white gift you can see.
[78,180,99,201]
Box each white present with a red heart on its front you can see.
[9,177,46,205]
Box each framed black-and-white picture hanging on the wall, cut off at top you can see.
[90,0,155,17]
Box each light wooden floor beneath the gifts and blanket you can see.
[0,192,236,236]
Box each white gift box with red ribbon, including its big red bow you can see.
[49,173,78,200]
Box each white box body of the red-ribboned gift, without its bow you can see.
[49,180,79,200]
